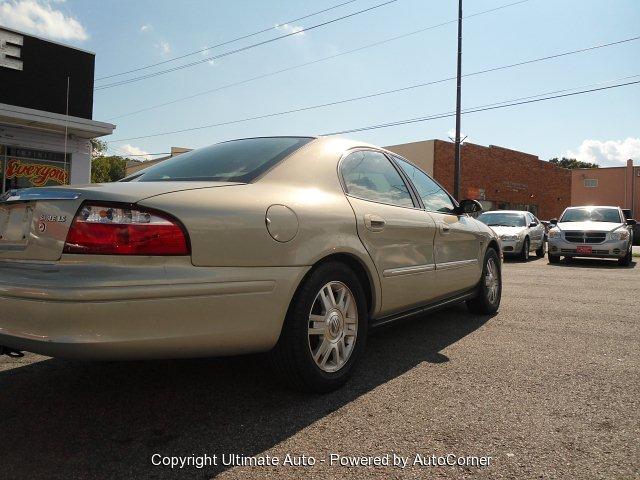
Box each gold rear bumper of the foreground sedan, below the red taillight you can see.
[0,255,309,360]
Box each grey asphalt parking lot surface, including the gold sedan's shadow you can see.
[0,258,640,479]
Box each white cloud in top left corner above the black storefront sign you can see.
[0,0,89,41]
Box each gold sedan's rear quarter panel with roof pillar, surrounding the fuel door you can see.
[140,139,381,315]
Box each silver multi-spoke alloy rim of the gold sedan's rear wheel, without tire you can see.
[308,281,358,373]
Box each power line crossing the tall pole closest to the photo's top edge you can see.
[108,0,530,120]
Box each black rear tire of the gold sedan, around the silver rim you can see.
[270,262,369,393]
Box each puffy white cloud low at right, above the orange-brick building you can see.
[562,137,640,167]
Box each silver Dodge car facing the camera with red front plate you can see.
[549,206,636,266]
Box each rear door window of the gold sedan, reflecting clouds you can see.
[340,150,414,207]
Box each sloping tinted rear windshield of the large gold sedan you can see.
[125,137,313,183]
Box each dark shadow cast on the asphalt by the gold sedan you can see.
[0,305,490,479]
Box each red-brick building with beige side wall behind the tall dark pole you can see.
[385,140,571,220]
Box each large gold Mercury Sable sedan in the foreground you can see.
[0,137,502,391]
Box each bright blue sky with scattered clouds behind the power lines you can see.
[0,0,640,165]
